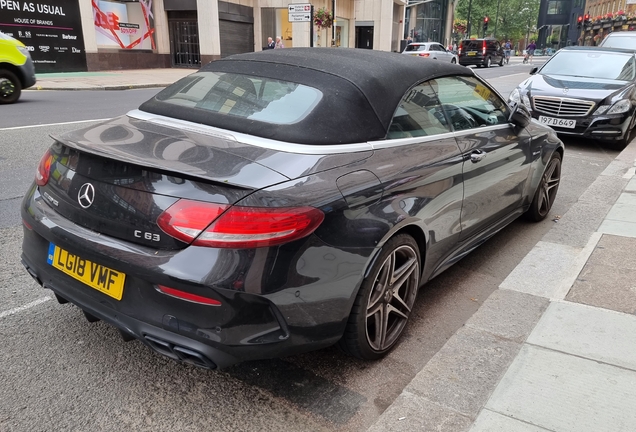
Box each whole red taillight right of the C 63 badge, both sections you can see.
[157,199,325,248]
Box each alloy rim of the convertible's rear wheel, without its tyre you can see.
[366,245,419,351]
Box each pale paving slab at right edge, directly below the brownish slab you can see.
[528,302,636,372]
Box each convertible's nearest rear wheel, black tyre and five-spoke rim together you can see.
[339,234,421,360]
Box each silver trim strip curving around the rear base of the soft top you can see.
[126,109,373,155]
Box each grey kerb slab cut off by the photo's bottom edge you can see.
[368,391,472,432]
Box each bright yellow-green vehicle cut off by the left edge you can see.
[0,32,36,105]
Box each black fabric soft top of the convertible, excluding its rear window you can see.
[140,48,474,144]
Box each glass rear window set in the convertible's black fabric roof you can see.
[157,72,323,124]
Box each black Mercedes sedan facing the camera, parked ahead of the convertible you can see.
[510,47,636,150]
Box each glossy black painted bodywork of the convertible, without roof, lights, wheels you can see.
[22,52,563,367]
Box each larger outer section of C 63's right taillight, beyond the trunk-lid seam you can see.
[193,206,325,248]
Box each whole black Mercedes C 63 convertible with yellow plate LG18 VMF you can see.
[21,48,564,368]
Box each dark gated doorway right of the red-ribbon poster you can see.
[168,18,201,69]
